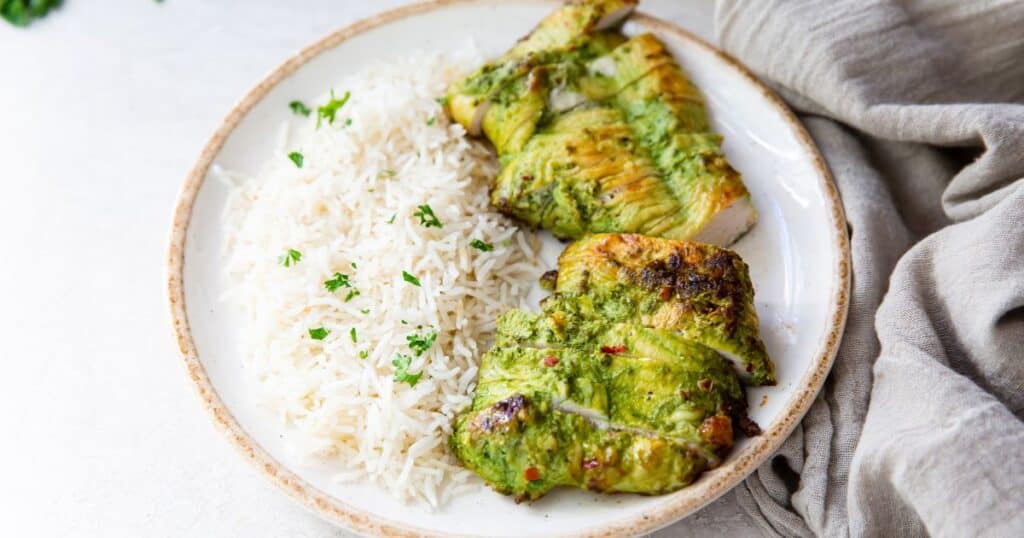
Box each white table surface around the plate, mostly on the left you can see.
[0,0,755,537]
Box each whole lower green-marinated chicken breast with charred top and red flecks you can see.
[451,234,774,500]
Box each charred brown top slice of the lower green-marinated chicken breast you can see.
[557,234,775,385]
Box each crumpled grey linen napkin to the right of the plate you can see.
[716,0,1024,537]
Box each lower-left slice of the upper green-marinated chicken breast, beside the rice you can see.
[490,107,686,239]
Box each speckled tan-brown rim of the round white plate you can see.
[166,0,851,536]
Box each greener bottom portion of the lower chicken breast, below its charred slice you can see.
[450,336,743,500]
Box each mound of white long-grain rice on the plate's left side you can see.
[221,52,541,506]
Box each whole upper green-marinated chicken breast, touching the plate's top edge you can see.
[447,0,756,245]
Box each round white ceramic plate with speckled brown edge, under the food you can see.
[169,0,849,536]
